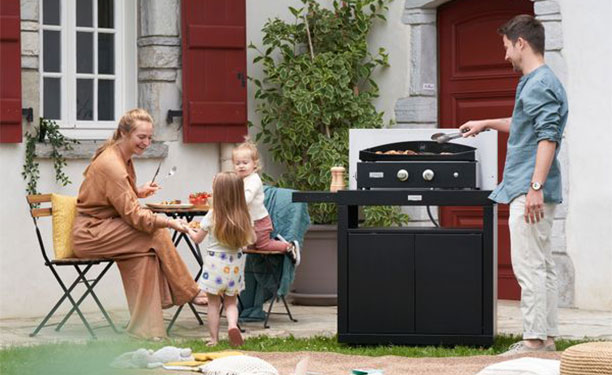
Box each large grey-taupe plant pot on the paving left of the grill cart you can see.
[289,224,338,306]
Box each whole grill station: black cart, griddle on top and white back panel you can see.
[293,129,497,346]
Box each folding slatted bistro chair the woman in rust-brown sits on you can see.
[26,194,119,338]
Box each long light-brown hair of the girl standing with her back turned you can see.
[212,172,255,249]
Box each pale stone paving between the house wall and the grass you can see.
[0,301,612,347]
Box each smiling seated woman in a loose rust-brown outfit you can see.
[73,109,206,338]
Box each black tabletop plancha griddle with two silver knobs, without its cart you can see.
[357,141,477,189]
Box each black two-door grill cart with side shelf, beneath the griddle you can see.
[293,189,497,346]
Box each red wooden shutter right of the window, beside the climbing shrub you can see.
[181,0,247,143]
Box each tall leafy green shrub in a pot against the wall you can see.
[249,0,409,306]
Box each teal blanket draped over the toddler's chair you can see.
[240,185,310,322]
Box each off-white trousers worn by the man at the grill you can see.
[508,195,559,340]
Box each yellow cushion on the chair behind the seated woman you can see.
[51,194,76,259]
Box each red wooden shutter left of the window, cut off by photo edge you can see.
[0,0,22,143]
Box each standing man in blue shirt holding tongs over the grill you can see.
[460,15,568,354]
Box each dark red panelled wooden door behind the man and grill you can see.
[438,0,533,299]
